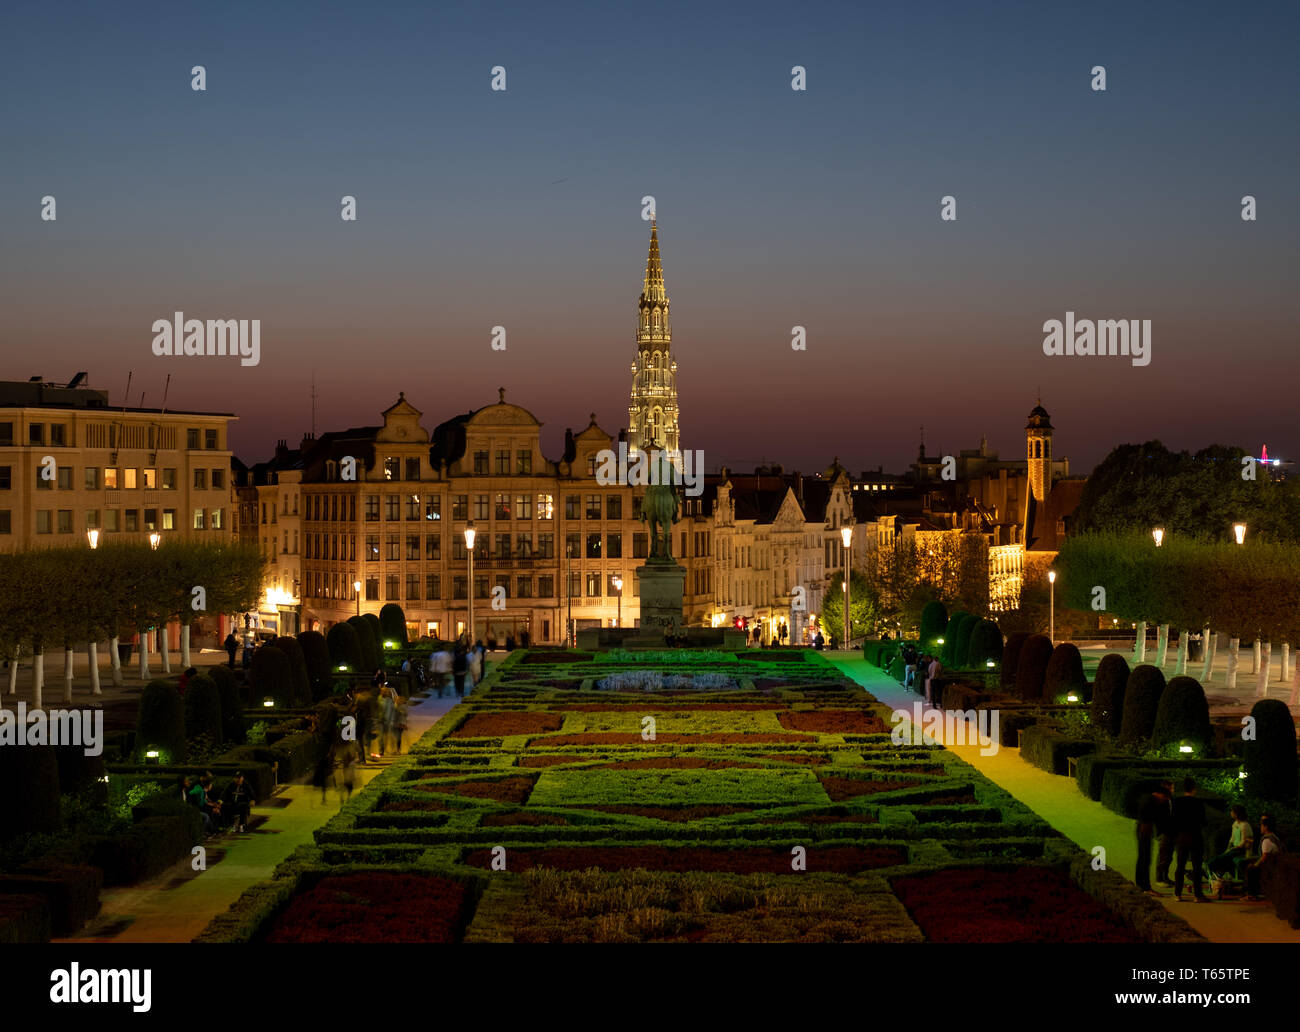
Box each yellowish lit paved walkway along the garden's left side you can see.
[56,681,458,942]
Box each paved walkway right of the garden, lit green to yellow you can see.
[826,652,1300,942]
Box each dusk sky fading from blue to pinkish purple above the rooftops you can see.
[0,0,1300,472]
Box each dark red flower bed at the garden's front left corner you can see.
[267,872,467,942]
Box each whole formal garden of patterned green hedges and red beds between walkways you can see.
[200,650,1200,942]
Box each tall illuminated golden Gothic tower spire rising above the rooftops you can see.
[628,222,680,455]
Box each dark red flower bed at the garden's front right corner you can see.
[893,867,1141,942]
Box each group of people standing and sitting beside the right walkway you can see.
[1135,777,1284,903]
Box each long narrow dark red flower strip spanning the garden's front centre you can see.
[465,846,907,875]
